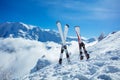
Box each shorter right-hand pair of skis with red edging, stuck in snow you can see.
[75,26,89,60]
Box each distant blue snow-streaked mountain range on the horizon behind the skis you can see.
[0,22,95,43]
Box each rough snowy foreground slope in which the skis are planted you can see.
[22,31,120,80]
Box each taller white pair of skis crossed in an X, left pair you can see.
[56,21,70,64]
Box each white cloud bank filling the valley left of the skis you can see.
[0,38,61,78]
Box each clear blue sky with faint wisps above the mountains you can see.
[0,0,120,37]
